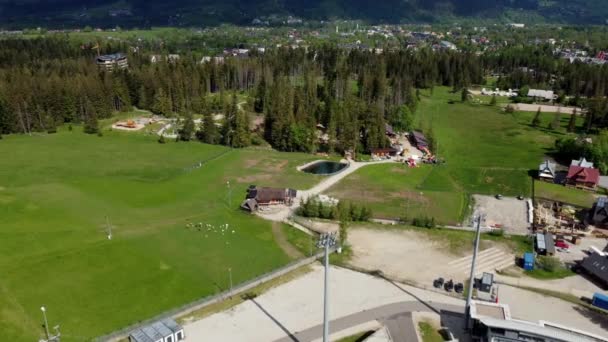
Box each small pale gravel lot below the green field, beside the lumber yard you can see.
[473,195,529,235]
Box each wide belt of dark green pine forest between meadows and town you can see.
[0,37,608,152]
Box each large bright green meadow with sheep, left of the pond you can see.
[0,127,318,341]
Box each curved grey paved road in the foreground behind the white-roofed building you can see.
[275,301,464,342]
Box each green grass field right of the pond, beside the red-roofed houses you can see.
[329,87,582,224]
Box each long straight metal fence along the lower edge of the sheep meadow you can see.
[94,248,336,342]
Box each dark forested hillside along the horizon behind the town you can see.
[0,0,608,28]
